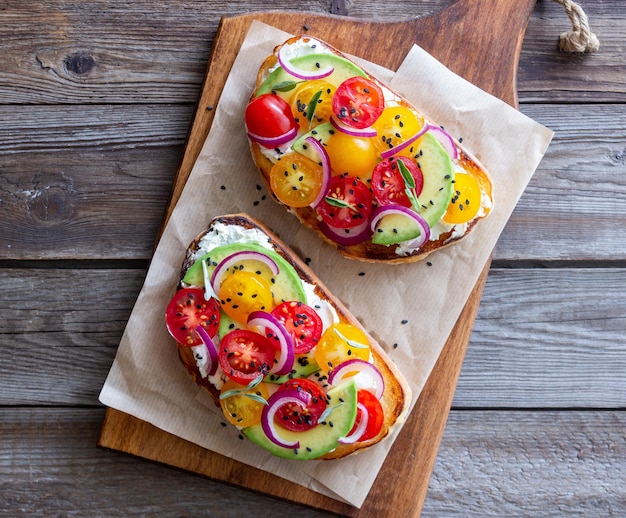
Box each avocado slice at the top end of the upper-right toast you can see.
[256,53,367,99]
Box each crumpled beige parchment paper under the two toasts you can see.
[100,22,552,507]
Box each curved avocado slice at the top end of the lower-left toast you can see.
[183,243,307,304]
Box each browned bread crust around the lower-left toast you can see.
[177,214,411,459]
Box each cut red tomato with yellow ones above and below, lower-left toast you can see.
[218,329,276,385]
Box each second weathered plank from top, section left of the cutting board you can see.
[0,105,192,259]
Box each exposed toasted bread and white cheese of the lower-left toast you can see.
[172,214,411,459]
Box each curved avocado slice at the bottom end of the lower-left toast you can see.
[243,380,357,460]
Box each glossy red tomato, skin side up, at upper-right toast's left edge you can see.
[245,94,298,142]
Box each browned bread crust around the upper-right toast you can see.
[249,36,493,264]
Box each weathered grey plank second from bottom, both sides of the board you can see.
[0,268,626,408]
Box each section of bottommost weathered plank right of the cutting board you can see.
[423,411,626,517]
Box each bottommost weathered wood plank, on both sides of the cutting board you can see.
[0,408,626,518]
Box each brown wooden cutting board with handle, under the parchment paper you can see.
[98,0,535,517]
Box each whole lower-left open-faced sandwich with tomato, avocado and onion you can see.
[165,214,411,460]
